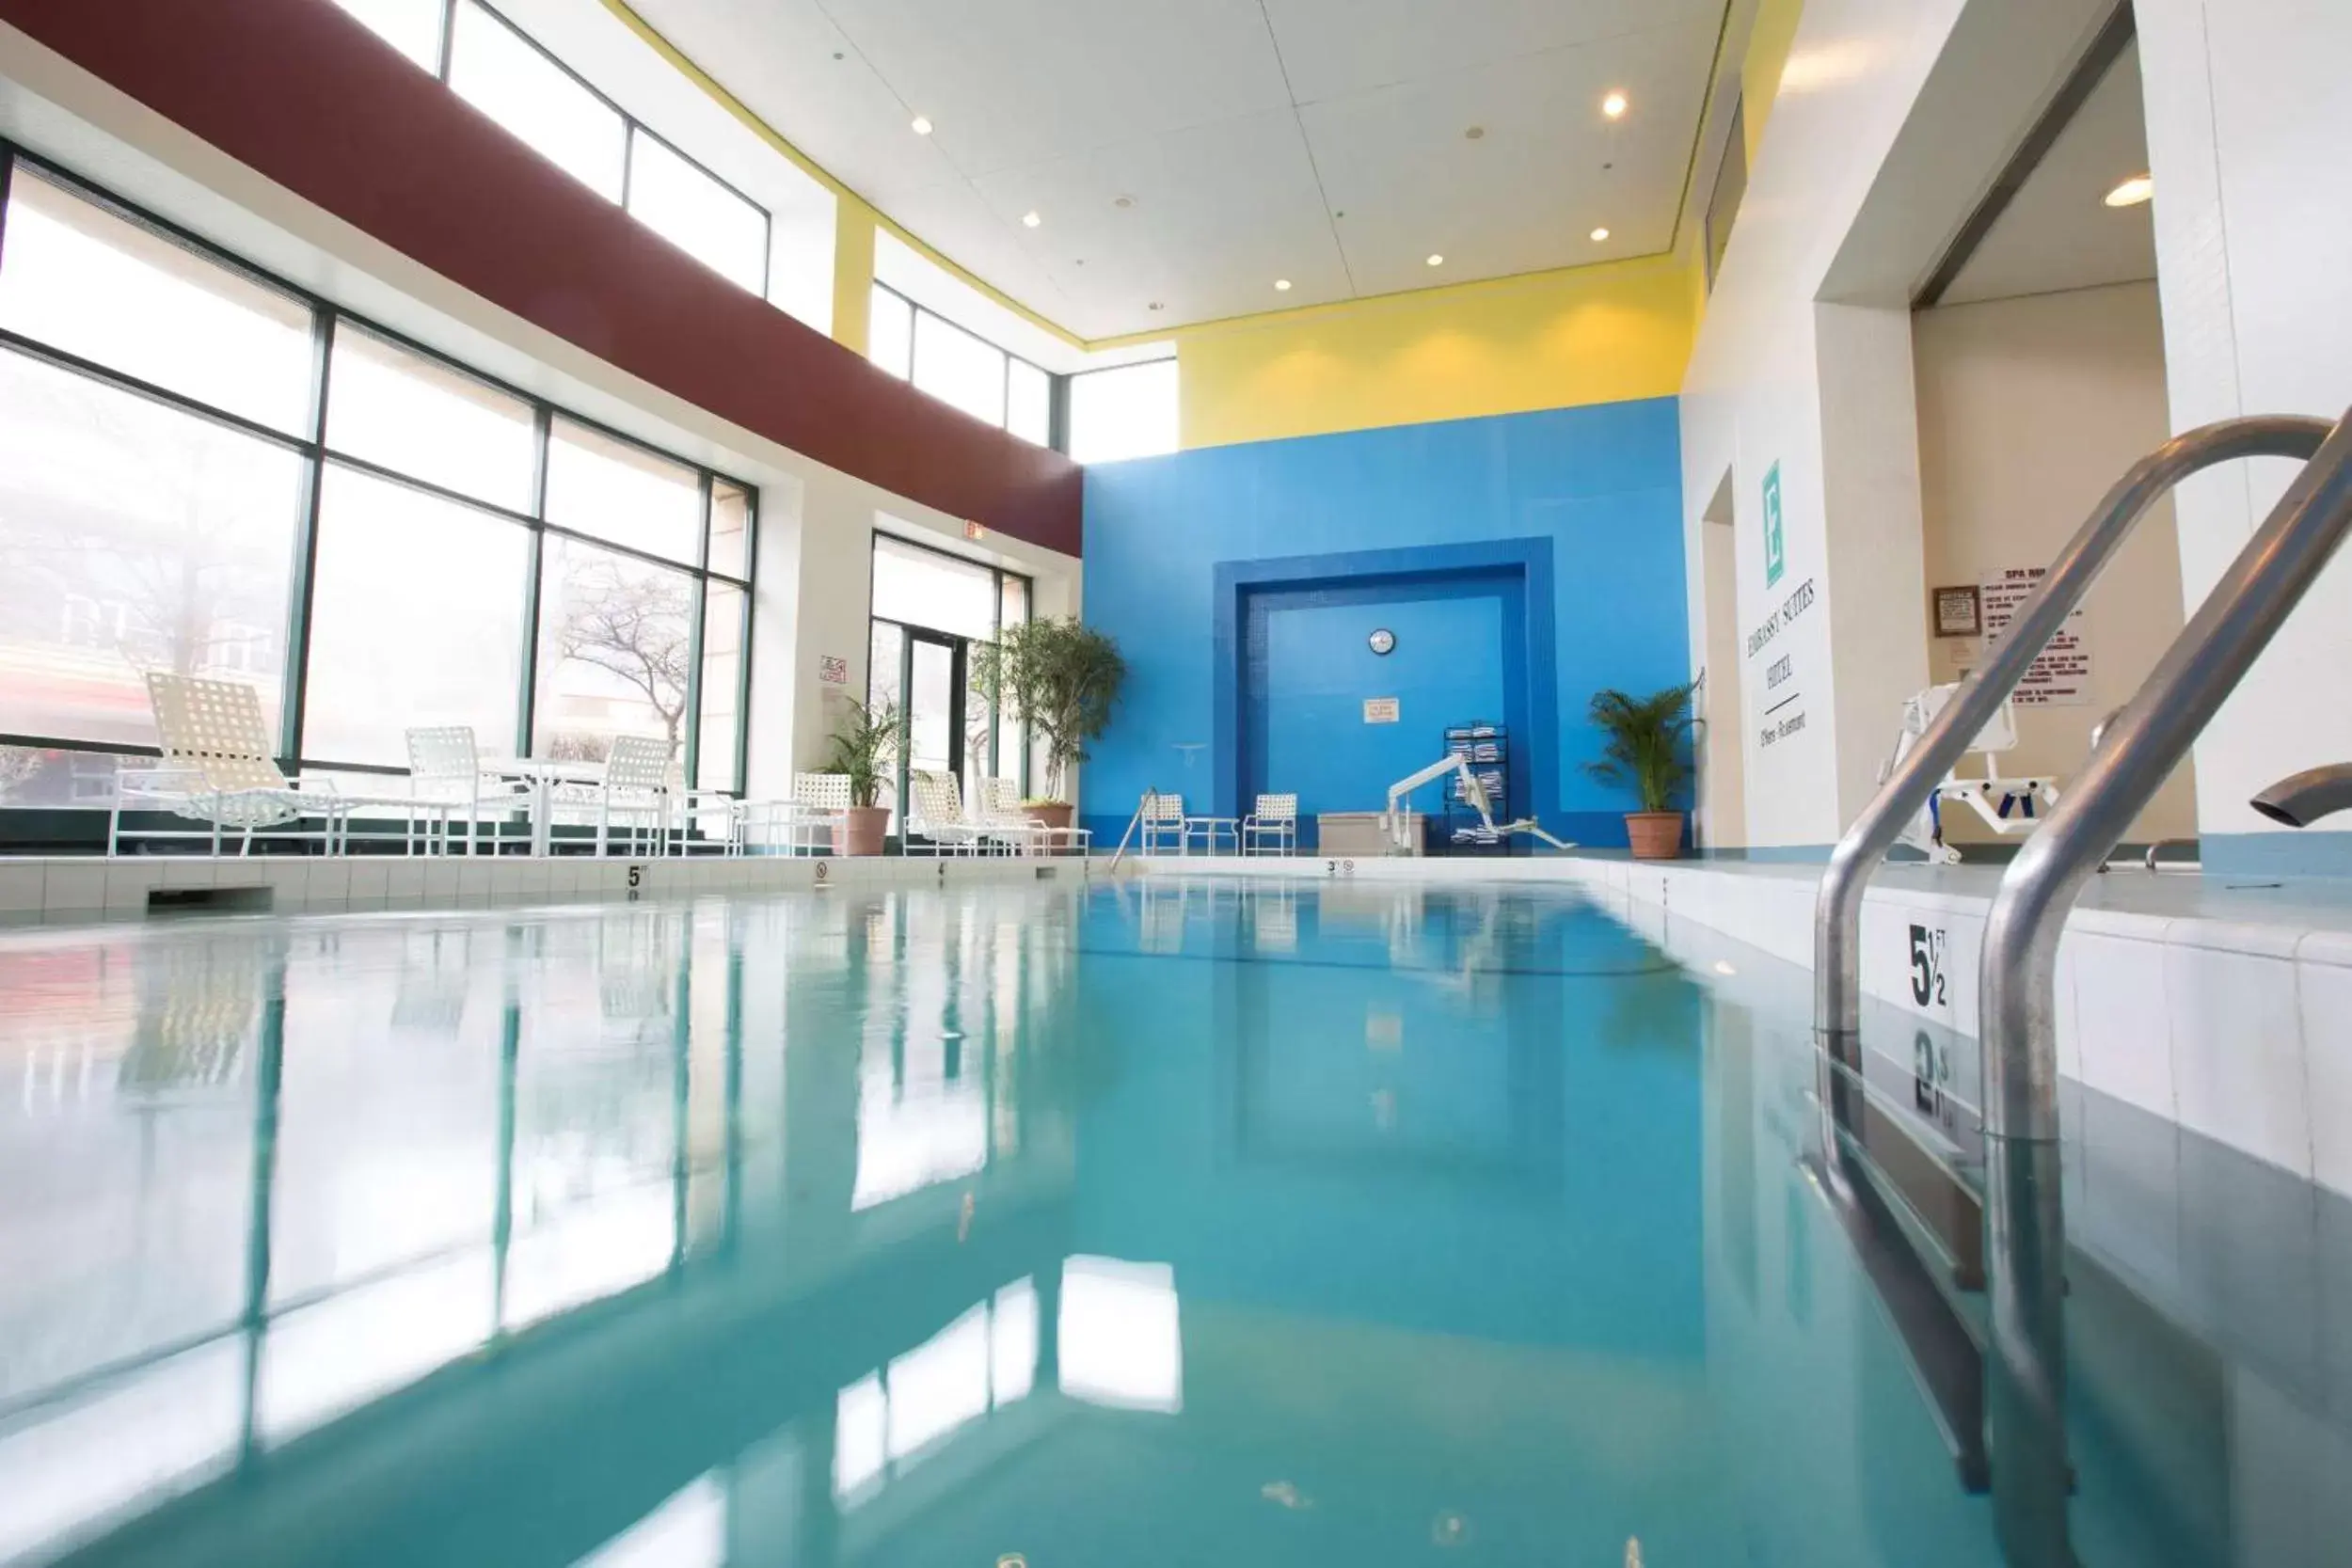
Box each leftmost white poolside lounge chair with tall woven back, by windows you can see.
[106,670,409,856]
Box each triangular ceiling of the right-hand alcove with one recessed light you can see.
[1943,44,2162,306]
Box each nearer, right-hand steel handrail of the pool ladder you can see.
[1979,414,2352,1568]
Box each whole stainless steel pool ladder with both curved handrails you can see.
[1814,414,2352,1568]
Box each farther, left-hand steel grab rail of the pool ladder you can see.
[1814,416,2328,1063]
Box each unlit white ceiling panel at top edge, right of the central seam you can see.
[1265,0,1724,103]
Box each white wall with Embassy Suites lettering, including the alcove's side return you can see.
[1682,0,2145,847]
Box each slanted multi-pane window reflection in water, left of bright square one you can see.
[833,1279,1038,1497]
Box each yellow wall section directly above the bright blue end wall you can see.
[1171,259,1696,449]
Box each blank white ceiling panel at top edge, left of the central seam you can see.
[823,0,1292,176]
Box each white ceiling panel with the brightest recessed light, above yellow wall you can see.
[1301,24,1715,293]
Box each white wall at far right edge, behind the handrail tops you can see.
[2136,0,2352,834]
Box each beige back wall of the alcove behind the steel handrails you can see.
[1915,282,2197,842]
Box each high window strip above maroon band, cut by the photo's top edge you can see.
[334,0,771,298]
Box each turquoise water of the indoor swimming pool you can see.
[0,877,2352,1568]
